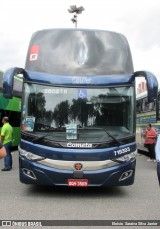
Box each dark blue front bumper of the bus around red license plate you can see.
[19,156,136,187]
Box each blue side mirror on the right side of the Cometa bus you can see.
[133,71,158,103]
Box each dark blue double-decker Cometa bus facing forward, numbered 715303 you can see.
[3,29,158,187]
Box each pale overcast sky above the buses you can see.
[0,0,160,82]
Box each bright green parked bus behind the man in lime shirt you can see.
[0,72,22,147]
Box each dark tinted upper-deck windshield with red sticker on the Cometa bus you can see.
[25,29,133,76]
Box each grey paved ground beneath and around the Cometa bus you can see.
[0,151,160,228]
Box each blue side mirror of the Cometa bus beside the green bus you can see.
[3,68,24,99]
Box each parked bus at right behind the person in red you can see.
[136,86,160,153]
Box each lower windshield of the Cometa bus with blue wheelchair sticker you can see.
[22,83,134,142]
